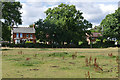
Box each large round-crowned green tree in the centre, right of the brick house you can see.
[35,3,92,44]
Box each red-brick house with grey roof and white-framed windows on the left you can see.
[11,26,36,44]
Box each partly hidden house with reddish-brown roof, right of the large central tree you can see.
[86,32,102,44]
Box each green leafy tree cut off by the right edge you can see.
[100,8,120,40]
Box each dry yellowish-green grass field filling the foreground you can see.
[2,48,118,78]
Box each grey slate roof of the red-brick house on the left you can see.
[13,27,35,33]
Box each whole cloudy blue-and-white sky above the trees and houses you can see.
[17,0,119,27]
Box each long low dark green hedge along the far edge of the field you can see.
[2,41,115,48]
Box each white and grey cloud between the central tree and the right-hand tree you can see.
[69,2,117,27]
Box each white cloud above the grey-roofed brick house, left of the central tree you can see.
[20,1,60,26]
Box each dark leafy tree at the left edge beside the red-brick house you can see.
[2,2,22,41]
